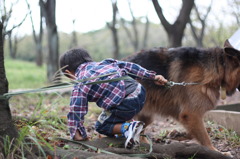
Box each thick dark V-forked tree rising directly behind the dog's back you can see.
[152,0,194,47]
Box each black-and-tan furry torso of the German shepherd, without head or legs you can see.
[128,47,223,119]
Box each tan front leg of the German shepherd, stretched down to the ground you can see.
[179,111,217,151]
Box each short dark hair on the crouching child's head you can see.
[60,48,93,72]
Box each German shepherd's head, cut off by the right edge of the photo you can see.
[224,47,240,95]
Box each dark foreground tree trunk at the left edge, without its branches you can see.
[0,21,18,142]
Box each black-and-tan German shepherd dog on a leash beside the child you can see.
[125,47,240,150]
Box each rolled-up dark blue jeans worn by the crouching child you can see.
[95,84,146,137]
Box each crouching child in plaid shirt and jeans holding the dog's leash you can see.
[60,48,167,148]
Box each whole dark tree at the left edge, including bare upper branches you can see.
[0,0,27,144]
